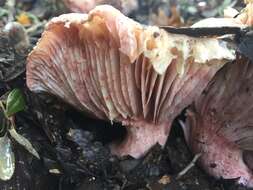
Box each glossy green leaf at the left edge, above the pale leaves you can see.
[5,89,25,117]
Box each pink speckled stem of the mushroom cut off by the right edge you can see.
[188,112,253,187]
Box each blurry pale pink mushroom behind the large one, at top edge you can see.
[63,0,138,14]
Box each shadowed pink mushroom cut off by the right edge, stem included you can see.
[184,58,253,187]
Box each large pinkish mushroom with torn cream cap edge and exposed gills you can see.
[26,5,235,158]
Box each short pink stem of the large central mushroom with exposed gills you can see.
[110,119,171,158]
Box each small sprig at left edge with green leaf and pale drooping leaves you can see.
[0,89,40,181]
